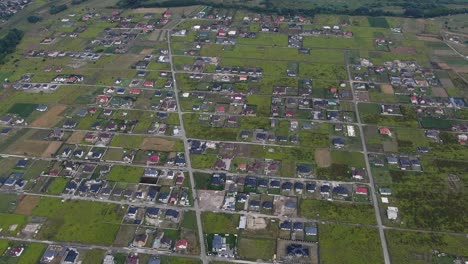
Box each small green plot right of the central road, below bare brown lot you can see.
[201,212,240,234]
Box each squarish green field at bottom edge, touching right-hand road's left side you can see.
[319,225,384,264]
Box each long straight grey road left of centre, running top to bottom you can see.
[167,28,208,264]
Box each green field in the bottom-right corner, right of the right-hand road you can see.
[385,230,468,264]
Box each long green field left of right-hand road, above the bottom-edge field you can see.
[299,200,375,224]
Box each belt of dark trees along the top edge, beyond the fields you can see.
[118,0,468,18]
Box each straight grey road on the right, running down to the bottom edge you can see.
[346,59,391,264]
